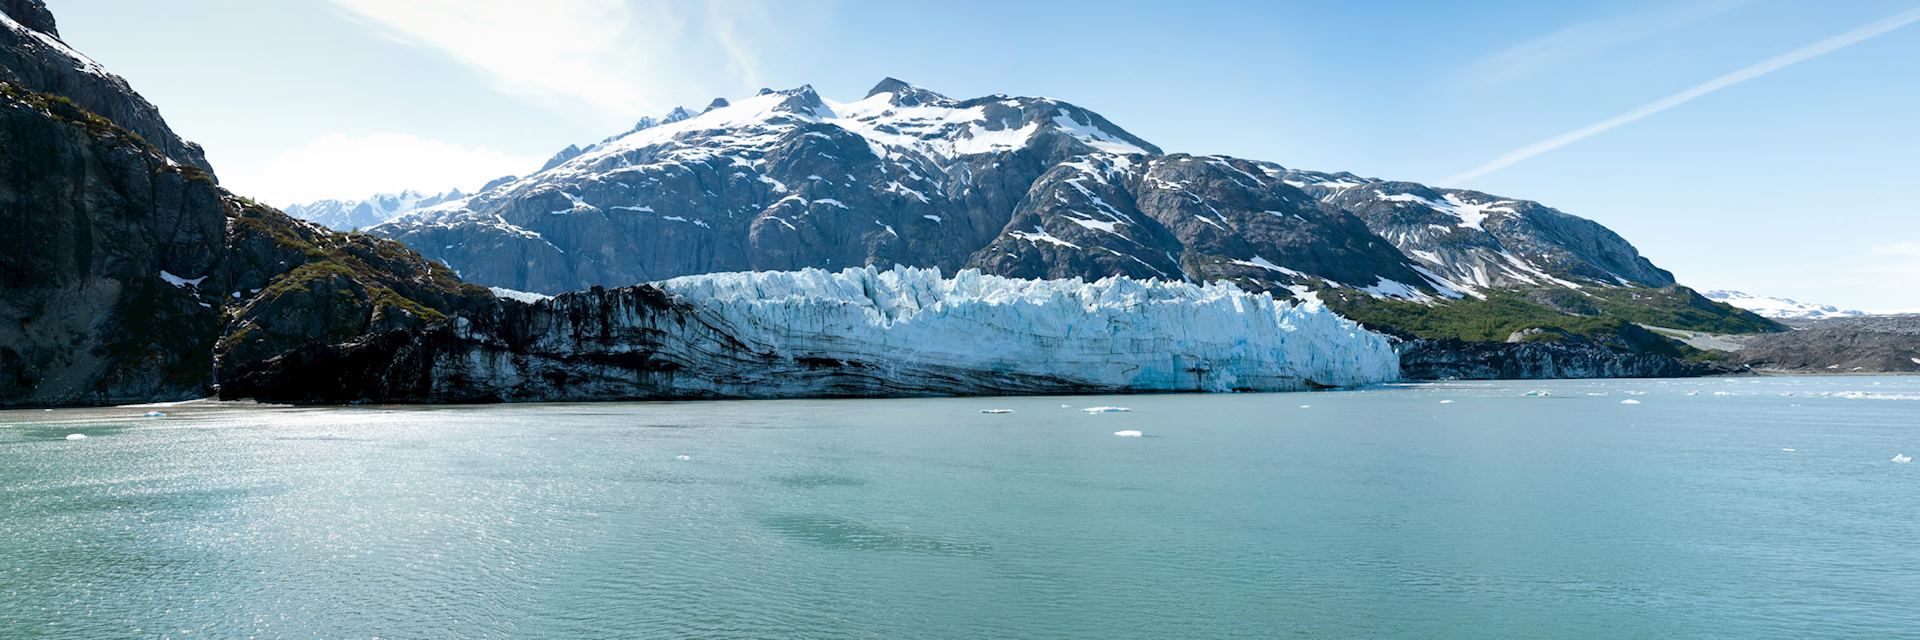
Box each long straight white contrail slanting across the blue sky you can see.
[1440,8,1920,185]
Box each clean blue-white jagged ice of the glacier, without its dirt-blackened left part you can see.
[659,267,1400,392]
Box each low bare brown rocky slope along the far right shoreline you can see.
[1734,315,1920,373]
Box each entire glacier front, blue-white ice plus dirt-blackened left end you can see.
[412,267,1400,402]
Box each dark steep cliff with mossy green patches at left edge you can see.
[0,7,493,406]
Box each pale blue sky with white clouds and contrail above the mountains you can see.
[48,0,1920,311]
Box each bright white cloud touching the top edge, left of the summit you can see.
[332,0,799,121]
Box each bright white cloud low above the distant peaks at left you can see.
[232,133,543,206]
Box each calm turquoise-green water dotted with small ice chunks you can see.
[0,377,1920,638]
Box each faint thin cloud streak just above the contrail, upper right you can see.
[1453,0,1749,85]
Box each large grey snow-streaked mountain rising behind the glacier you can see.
[374,79,1672,300]
